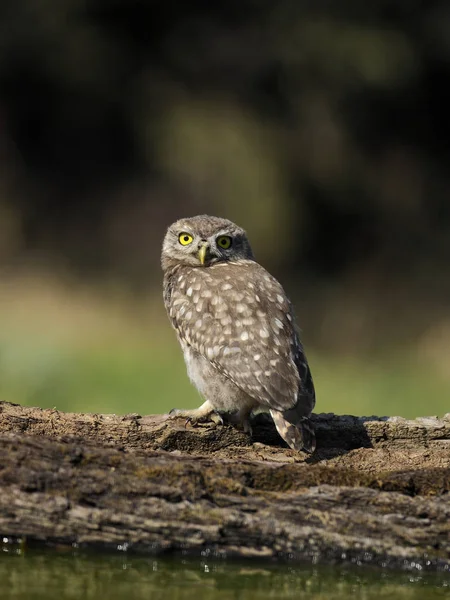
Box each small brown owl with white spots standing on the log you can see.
[161,215,315,452]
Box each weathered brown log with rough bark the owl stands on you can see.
[0,403,450,569]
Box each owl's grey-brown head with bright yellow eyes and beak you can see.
[161,215,253,270]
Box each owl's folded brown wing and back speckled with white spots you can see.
[169,261,314,416]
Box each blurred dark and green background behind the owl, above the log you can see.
[0,0,450,417]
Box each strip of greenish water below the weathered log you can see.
[0,540,450,600]
